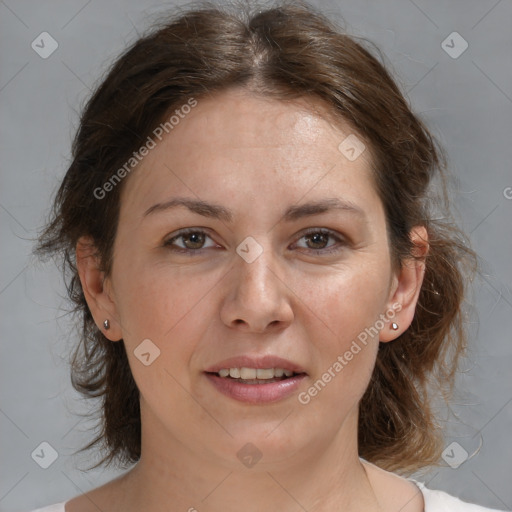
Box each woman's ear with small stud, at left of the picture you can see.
[76,237,122,341]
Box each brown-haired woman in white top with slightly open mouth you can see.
[32,4,504,512]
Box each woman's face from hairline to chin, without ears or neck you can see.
[92,90,414,466]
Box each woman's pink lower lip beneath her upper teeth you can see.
[205,373,307,404]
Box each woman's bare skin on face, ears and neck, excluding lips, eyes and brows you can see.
[72,89,428,512]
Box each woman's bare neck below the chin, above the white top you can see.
[118,403,379,512]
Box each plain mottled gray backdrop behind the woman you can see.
[0,0,512,511]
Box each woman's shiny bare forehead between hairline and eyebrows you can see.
[118,89,373,220]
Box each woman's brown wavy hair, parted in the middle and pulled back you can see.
[35,2,476,472]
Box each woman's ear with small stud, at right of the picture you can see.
[379,226,429,342]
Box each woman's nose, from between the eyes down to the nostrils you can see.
[221,244,293,333]
